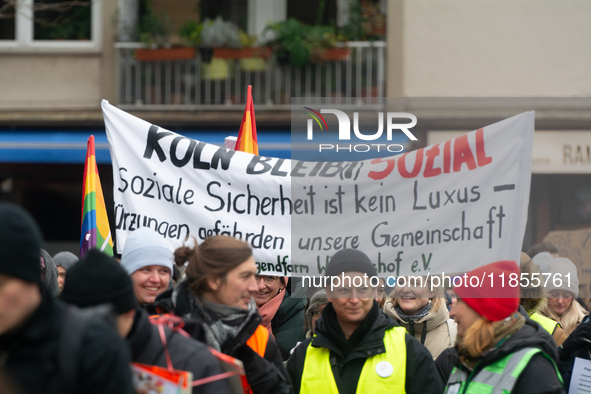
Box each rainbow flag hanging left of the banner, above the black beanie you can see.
[80,135,113,258]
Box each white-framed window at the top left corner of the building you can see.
[0,0,101,52]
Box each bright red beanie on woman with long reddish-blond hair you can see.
[454,261,521,322]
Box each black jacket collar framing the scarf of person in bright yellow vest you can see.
[311,302,398,362]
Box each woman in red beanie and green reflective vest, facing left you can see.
[438,261,564,394]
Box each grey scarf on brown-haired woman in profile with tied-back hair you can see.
[190,297,257,353]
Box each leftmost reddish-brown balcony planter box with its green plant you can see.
[135,13,195,62]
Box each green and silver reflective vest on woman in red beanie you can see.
[444,348,562,394]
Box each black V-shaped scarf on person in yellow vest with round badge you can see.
[322,301,379,358]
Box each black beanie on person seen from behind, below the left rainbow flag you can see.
[60,249,137,314]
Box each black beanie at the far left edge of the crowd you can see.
[0,203,42,283]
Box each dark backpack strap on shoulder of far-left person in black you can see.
[58,305,117,392]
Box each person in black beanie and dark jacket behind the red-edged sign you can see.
[61,249,232,394]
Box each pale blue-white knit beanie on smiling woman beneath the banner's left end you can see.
[121,227,174,275]
